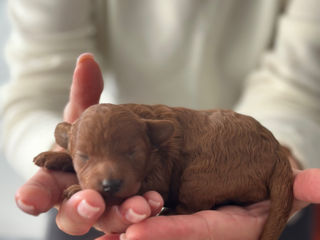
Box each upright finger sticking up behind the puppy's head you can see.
[64,53,103,122]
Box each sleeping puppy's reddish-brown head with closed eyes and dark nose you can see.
[55,104,174,200]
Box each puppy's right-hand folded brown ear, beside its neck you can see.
[145,119,174,146]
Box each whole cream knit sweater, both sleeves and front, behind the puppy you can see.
[1,0,320,177]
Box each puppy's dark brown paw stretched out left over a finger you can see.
[33,151,74,172]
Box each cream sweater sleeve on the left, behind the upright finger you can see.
[0,0,95,177]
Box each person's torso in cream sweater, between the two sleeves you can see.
[96,0,280,109]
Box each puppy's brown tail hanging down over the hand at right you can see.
[260,146,293,240]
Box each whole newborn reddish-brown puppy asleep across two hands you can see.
[34,104,293,240]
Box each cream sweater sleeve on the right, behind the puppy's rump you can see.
[237,0,320,167]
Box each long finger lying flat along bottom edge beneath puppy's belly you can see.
[120,208,266,240]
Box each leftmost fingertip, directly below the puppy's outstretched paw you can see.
[15,168,77,215]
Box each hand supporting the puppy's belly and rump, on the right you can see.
[95,169,320,240]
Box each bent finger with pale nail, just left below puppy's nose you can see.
[56,189,105,235]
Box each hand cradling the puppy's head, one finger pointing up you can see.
[16,54,163,235]
